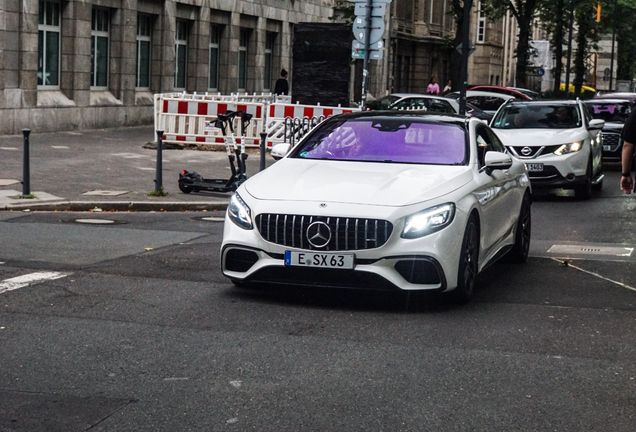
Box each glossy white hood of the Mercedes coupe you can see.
[244,159,472,206]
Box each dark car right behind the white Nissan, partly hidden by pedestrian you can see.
[584,98,636,162]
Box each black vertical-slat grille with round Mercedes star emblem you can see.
[256,214,393,251]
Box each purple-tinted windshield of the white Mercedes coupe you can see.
[290,117,466,165]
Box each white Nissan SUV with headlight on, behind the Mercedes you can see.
[491,100,605,199]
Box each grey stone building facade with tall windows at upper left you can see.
[0,0,333,135]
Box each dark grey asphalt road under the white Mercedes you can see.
[0,171,636,432]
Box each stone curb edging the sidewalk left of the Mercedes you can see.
[0,201,228,212]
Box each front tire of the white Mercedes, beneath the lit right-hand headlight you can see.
[450,216,479,304]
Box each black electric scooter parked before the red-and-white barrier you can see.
[179,110,252,193]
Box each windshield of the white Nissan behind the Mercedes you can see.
[493,103,582,129]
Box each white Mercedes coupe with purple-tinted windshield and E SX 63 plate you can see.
[221,111,531,302]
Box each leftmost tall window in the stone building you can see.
[38,1,60,88]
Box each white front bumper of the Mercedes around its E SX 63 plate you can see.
[221,203,466,291]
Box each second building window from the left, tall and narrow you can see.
[91,8,110,89]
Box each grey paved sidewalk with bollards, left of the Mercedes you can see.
[0,126,274,211]
